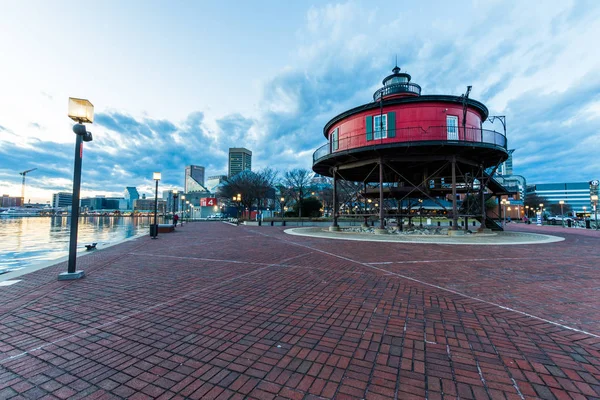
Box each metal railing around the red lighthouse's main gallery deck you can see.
[313,126,507,164]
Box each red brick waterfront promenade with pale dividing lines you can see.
[0,222,600,399]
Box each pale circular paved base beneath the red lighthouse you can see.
[284,227,565,245]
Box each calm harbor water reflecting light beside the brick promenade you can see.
[0,216,161,269]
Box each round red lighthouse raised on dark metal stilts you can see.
[313,66,508,233]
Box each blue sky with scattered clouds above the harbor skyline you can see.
[0,0,600,202]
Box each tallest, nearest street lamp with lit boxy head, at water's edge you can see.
[60,97,94,281]
